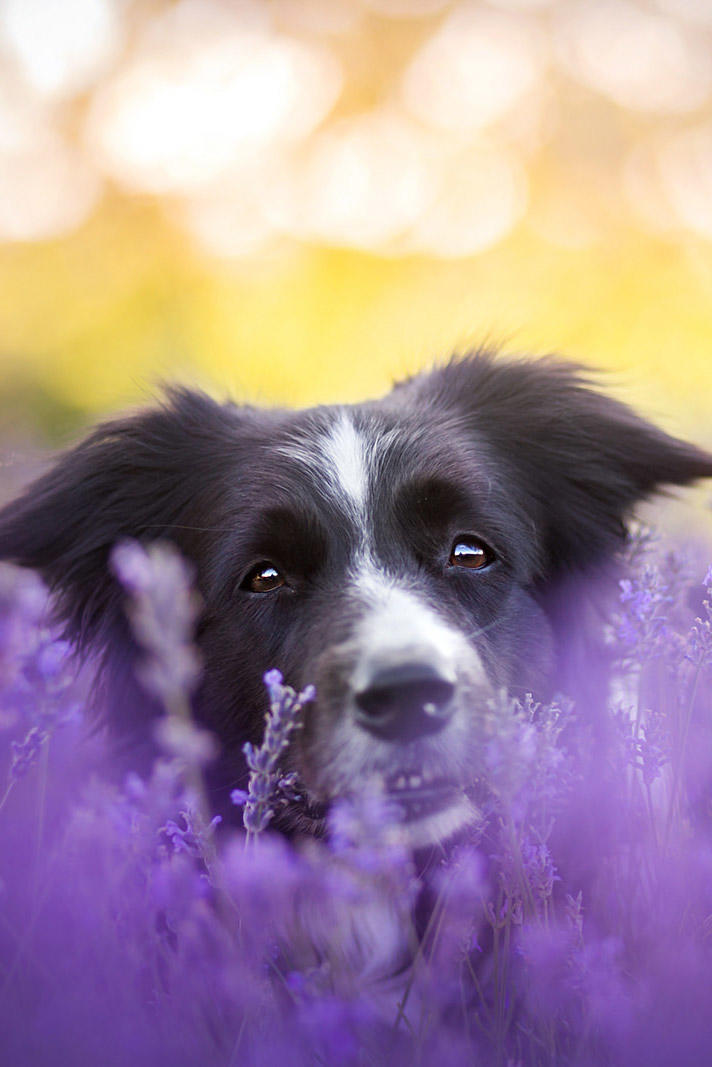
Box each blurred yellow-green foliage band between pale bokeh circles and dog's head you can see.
[0,198,712,434]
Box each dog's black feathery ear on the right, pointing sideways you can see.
[406,352,712,575]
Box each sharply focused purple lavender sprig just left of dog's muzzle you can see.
[231,670,316,835]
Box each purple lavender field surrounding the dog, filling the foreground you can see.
[0,535,712,1067]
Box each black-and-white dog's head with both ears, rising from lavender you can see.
[0,353,712,845]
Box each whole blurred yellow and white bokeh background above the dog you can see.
[0,0,712,454]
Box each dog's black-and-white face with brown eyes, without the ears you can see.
[202,396,552,843]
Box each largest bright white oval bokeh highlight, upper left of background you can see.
[88,2,342,194]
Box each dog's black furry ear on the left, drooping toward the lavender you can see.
[0,389,245,643]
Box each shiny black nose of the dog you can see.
[354,664,455,740]
